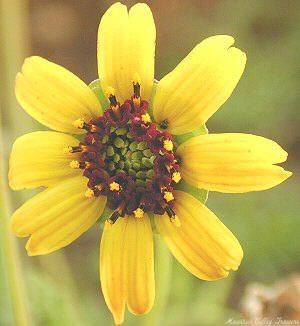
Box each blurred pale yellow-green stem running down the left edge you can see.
[0,0,32,326]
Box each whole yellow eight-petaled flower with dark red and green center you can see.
[9,3,291,324]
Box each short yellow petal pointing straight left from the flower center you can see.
[8,131,82,190]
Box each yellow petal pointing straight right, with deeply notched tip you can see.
[176,134,291,192]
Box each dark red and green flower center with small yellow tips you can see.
[68,83,181,223]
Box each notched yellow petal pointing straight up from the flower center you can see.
[98,2,156,102]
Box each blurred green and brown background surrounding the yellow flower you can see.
[0,0,300,326]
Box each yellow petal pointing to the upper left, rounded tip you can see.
[15,56,102,134]
